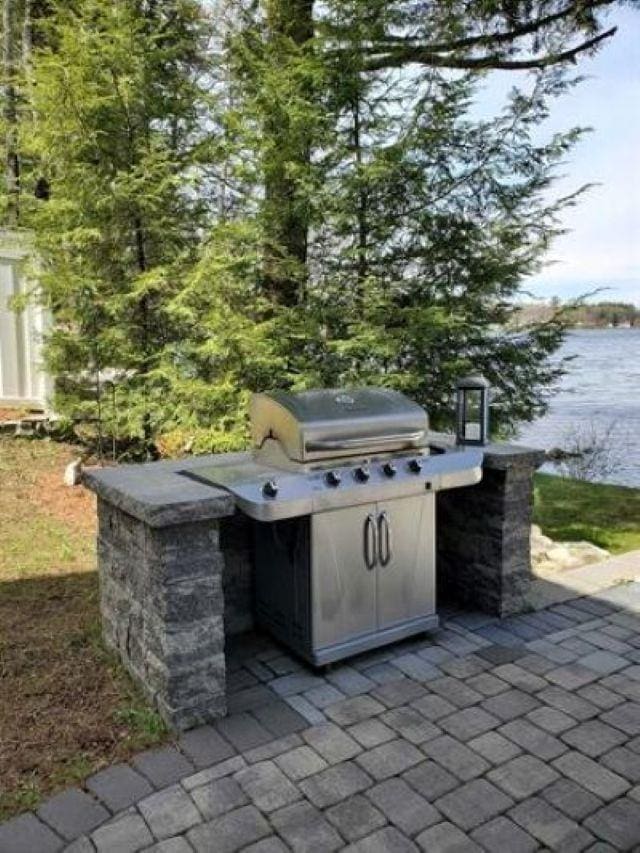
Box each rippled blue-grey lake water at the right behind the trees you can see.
[518,328,640,487]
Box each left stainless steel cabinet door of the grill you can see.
[311,504,377,648]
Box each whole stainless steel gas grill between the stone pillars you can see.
[191,388,482,666]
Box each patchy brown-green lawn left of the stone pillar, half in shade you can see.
[0,438,168,820]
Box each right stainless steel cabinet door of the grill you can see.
[376,494,436,628]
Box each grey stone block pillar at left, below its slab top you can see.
[98,498,226,730]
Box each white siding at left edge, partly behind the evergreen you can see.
[0,231,52,409]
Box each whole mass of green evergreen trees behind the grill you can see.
[2,0,616,455]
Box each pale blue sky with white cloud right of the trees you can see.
[487,6,640,306]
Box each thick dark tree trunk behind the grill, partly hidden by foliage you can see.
[264,0,314,306]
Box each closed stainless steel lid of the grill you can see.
[251,388,429,462]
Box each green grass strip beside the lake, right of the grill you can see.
[534,474,640,554]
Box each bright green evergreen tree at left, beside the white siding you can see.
[17,0,211,451]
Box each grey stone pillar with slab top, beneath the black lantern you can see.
[437,444,545,616]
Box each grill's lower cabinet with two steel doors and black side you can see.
[255,495,438,666]
